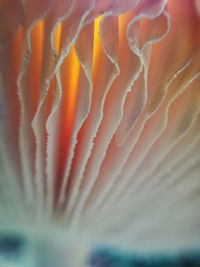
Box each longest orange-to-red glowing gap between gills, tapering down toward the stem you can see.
[56,47,80,186]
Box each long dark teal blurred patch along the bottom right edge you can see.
[88,248,200,267]
